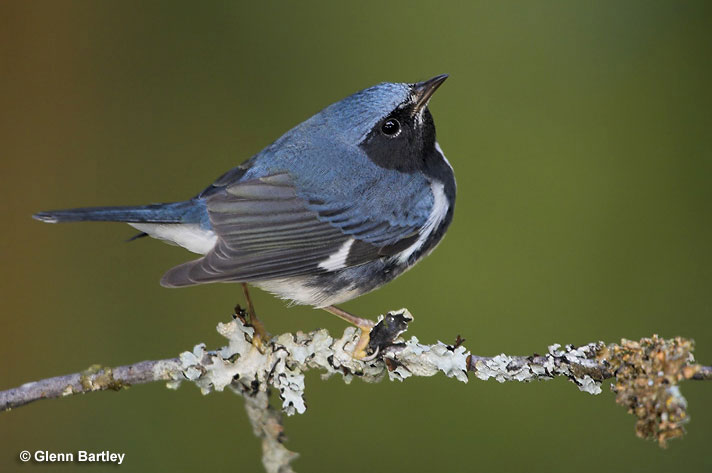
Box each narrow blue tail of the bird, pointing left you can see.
[32,200,200,223]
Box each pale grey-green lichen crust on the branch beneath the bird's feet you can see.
[170,310,469,415]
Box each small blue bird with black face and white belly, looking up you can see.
[33,74,456,359]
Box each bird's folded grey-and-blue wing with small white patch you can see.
[161,173,429,287]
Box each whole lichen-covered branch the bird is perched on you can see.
[0,309,712,472]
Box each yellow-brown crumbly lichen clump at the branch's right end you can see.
[598,335,700,447]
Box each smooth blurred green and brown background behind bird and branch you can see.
[0,1,712,472]
